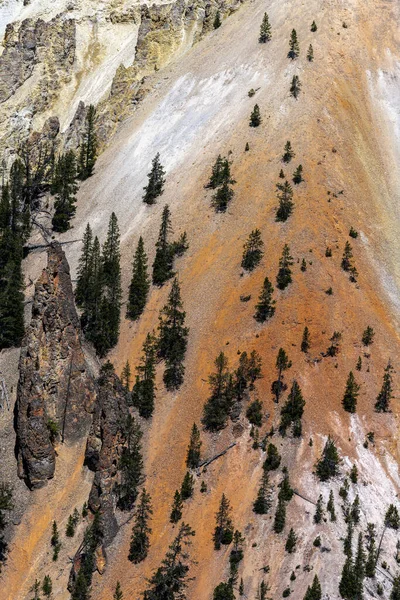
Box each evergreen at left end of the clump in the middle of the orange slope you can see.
[203,352,234,431]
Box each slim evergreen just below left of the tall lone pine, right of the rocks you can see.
[132,333,156,419]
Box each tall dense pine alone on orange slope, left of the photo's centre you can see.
[158,278,189,390]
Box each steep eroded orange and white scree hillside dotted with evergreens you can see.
[1,0,400,600]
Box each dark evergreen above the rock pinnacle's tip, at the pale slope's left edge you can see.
[52,150,78,233]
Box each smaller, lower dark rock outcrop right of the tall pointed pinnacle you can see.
[85,365,129,546]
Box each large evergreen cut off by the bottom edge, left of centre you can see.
[143,523,195,600]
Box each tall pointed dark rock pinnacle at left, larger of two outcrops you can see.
[16,243,95,488]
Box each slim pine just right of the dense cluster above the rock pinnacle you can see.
[126,236,150,321]
